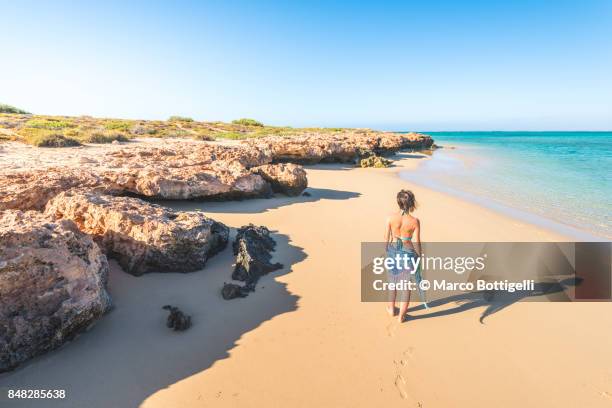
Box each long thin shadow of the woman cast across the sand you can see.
[408,278,581,323]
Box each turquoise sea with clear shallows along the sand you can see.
[402,132,612,239]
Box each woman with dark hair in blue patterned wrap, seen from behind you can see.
[385,190,421,323]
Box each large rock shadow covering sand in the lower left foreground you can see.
[0,233,307,408]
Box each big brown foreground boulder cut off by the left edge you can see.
[0,210,111,372]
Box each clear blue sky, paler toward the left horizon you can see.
[0,0,612,130]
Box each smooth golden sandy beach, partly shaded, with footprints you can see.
[0,153,612,408]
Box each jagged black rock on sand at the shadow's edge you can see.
[232,224,283,291]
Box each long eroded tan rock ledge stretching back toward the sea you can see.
[0,131,433,210]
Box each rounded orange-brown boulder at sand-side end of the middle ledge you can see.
[251,163,308,196]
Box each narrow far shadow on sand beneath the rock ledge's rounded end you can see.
[155,188,360,218]
